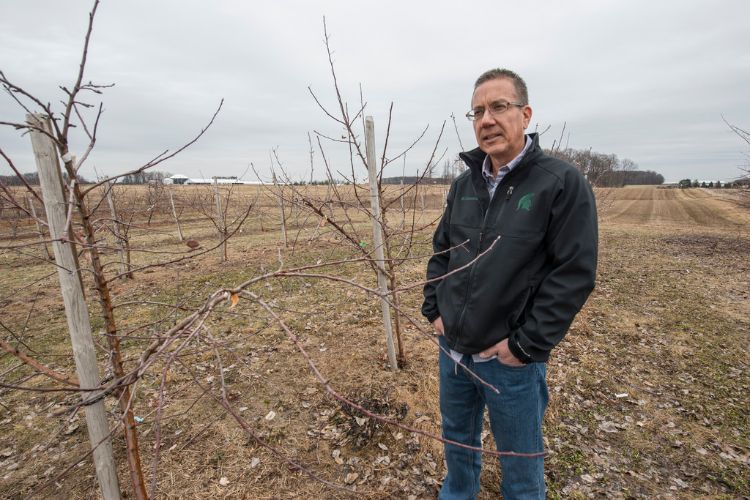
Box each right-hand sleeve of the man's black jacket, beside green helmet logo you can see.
[508,168,598,363]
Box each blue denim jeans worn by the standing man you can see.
[438,337,548,500]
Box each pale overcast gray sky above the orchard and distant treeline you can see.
[0,0,750,181]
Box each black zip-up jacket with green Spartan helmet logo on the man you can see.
[422,134,598,363]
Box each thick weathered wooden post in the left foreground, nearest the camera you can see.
[26,114,120,500]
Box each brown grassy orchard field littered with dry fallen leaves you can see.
[0,186,750,499]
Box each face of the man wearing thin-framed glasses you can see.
[471,78,531,170]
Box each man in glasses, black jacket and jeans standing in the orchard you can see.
[422,69,597,499]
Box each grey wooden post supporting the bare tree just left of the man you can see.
[365,116,398,371]
